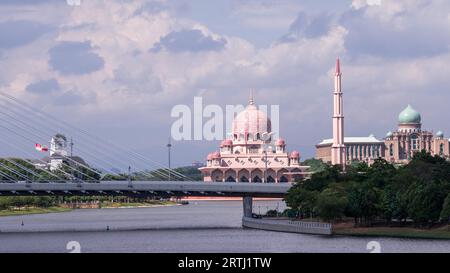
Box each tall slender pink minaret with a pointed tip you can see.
[331,58,346,171]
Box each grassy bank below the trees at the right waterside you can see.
[333,224,450,240]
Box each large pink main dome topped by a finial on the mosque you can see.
[232,98,272,136]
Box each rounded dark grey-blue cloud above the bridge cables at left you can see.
[49,41,104,75]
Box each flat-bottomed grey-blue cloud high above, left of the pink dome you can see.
[151,29,227,52]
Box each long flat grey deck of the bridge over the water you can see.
[0,181,292,197]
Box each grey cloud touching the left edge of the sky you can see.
[0,20,53,49]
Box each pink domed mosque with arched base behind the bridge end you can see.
[199,98,310,183]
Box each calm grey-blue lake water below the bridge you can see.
[0,201,450,252]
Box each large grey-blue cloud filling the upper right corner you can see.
[339,0,450,58]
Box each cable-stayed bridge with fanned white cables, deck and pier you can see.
[0,92,291,216]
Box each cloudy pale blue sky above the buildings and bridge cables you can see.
[0,0,450,166]
